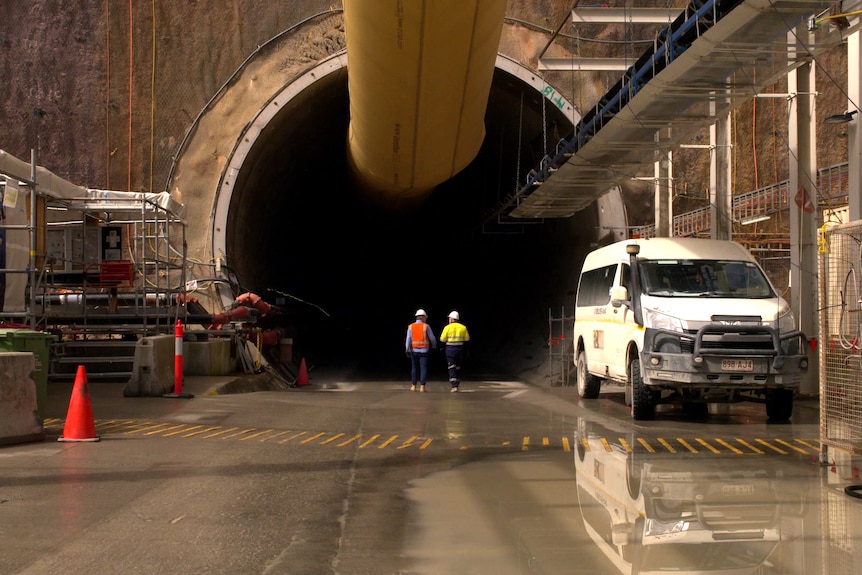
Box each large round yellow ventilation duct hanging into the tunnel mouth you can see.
[343,0,506,207]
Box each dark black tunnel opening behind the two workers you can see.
[226,70,608,379]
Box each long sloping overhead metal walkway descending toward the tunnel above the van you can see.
[506,0,840,218]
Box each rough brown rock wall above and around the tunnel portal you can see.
[0,0,847,224]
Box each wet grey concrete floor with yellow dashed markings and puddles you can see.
[0,372,862,575]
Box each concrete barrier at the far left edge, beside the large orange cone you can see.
[0,352,45,445]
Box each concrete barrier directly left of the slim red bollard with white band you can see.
[123,335,175,397]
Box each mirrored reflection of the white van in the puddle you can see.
[575,420,782,575]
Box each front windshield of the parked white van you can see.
[639,260,775,298]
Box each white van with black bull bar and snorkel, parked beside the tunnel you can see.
[573,238,808,420]
